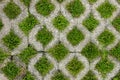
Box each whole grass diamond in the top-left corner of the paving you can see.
[3,2,21,19]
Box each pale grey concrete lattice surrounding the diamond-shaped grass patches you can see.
[0,0,120,80]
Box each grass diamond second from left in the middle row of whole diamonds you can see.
[36,26,53,47]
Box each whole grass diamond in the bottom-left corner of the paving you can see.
[2,62,20,80]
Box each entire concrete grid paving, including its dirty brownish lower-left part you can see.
[0,0,120,80]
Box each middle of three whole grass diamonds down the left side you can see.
[2,30,21,50]
